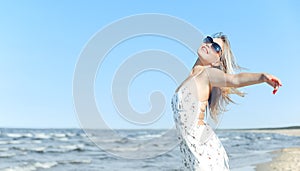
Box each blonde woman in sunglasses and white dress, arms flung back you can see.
[171,33,281,171]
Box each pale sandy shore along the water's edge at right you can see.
[254,129,300,171]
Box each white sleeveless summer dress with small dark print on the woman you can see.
[171,67,229,171]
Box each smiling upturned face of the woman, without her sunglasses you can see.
[198,38,224,65]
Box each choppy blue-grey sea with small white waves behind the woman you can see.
[0,128,300,171]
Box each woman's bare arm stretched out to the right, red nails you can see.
[206,68,281,94]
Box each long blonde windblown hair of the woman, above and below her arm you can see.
[208,32,244,122]
